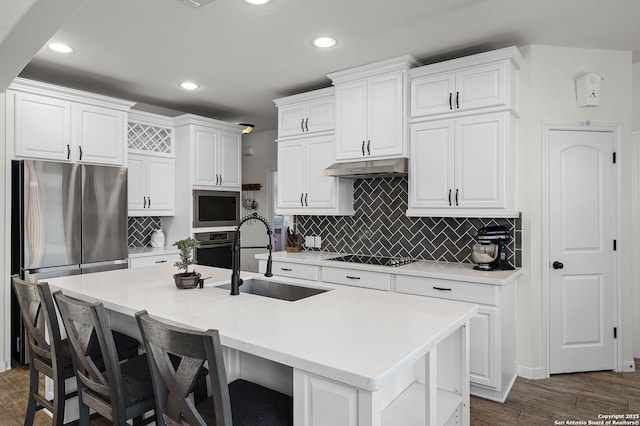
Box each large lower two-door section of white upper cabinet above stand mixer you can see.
[407,112,517,217]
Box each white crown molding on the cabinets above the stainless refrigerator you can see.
[7,77,136,112]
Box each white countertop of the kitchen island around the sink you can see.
[49,265,477,391]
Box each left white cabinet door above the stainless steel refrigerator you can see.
[15,93,72,161]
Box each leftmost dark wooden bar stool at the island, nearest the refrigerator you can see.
[11,275,140,426]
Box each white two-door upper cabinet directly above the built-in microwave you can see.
[175,114,242,191]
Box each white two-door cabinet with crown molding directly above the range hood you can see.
[328,56,417,161]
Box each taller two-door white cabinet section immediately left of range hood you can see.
[276,135,355,215]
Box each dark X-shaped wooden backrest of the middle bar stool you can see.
[53,291,127,424]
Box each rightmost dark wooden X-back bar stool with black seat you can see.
[136,311,293,426]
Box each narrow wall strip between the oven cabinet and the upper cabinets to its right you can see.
[240,130,278,272]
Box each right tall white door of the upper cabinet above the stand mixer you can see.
[455,113,506,208]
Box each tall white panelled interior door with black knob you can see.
[549,130,617,374]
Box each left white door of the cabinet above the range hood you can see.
[336,81,367,160]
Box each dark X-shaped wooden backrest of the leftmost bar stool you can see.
[11,275,64,372]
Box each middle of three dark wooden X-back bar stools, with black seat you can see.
[53,291,156,426]
